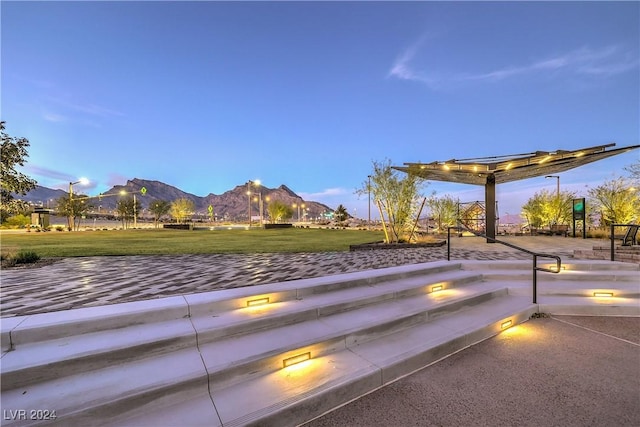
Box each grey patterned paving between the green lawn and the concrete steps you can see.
[0,236,608,317]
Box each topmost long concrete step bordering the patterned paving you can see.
[1,262,460,351]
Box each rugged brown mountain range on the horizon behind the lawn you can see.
[15,178,333,221]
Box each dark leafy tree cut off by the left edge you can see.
[0,121,36,218]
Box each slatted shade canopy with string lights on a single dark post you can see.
[393,143,640,242]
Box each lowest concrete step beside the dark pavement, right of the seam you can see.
[161,296,535,426]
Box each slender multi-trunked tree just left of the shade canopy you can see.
[356,160,424,242]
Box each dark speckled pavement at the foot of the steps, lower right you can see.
[305,316,640,427]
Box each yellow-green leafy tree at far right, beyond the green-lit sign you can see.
[588,178,640,225]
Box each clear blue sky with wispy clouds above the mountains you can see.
[0,1,640,217]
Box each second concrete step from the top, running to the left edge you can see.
[2,270,481,390]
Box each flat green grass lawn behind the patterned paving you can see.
[0,228,384,257]
